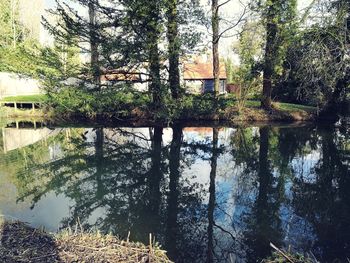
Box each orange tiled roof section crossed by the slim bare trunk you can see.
[184,62,227,80]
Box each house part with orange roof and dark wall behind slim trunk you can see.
[183,62,227,94]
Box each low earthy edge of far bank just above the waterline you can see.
[0,104,318,126]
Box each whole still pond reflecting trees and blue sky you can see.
[0,120,350,262]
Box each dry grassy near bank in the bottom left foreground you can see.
[0,221,171,263]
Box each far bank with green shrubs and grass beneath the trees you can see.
[0,94,317,124]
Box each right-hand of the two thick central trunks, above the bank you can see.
[167,0,181,99]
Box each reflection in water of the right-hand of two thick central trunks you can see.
[166,126,182,262]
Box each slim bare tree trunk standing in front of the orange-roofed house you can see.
[211,0,220,97]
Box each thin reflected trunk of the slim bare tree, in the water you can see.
[207,128,219,262]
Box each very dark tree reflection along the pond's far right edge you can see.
[293,127,350,262]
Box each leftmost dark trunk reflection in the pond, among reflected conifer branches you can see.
[95,128,104,198]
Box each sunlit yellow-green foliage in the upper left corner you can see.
[0,0,80,84]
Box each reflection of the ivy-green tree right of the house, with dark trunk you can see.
[232,126,318,262]
